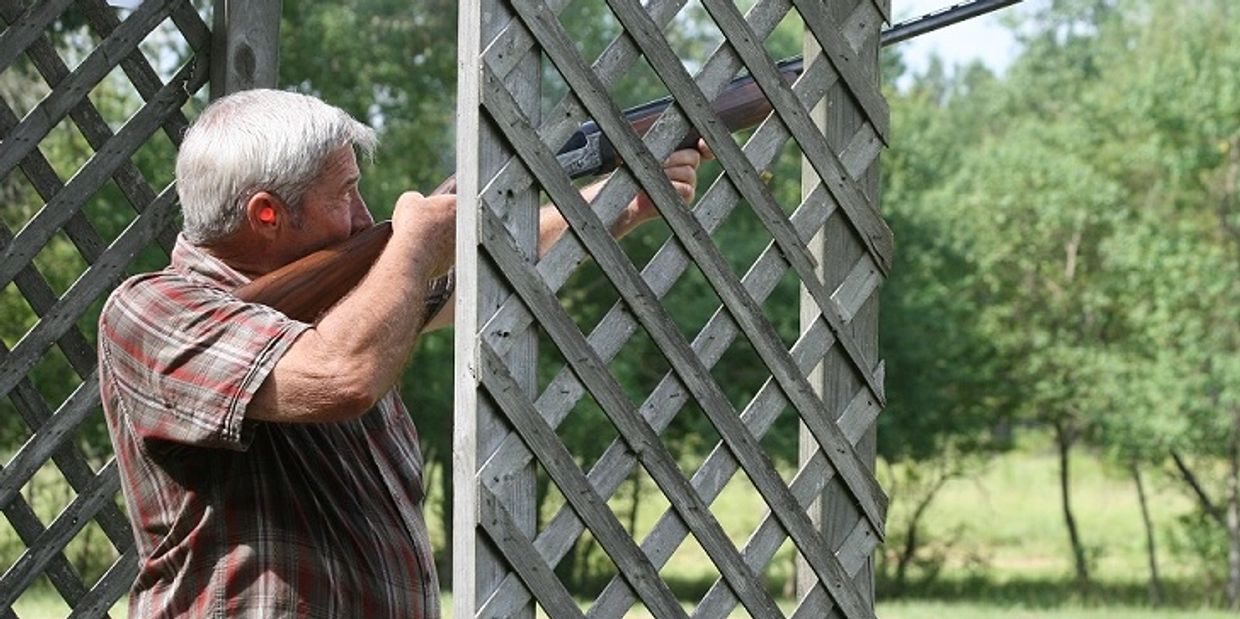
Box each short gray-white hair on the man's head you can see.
[176,89,377,244]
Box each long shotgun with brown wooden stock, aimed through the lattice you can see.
[233,0,1022,323]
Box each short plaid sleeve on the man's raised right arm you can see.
[99,272,310,450]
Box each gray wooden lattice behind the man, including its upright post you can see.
[0,0,280,617]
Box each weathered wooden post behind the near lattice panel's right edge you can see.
[797,0,892,605]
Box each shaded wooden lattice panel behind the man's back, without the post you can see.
[0,0,211,617]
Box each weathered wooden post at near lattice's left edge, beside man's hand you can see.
[451,0,541,618]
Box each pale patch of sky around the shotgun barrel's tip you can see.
[892,0,1050,79]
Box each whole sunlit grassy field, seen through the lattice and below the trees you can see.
[10,438,1235,619]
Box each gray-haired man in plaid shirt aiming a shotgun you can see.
[99,91,708,619]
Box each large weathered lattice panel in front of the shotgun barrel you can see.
[454,0,892,618]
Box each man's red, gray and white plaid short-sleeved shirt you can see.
[99,238,439,619]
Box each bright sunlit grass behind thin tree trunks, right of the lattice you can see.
[912,438,1199,583]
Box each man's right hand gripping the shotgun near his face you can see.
[392,191,456,278]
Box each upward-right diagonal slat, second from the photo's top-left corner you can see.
[0,0,180,183]
